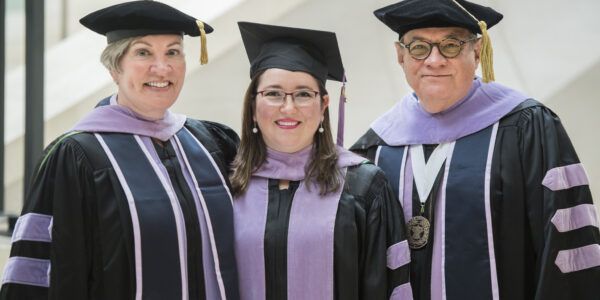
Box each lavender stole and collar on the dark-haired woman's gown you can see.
[234,146,365,300]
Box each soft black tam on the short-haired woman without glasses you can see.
[79,1,213,43]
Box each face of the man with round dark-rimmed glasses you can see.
[396,27,481,113]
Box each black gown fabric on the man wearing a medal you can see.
[350,100,600,300]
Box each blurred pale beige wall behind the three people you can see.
[0,0,600,274]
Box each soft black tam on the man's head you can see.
[373,0,502,36]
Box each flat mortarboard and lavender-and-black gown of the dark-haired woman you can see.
[233,22,412,300]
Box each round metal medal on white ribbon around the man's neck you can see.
[406,143,450,249]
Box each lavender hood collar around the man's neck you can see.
[371,78,529,146]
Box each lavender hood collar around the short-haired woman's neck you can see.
[70,94,186,141]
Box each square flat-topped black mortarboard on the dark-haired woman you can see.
[238,22,344,83]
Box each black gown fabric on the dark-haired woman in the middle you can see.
[255,164,409,300]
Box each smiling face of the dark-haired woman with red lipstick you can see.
[253,69,329,153]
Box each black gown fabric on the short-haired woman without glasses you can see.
[0,119,239,300]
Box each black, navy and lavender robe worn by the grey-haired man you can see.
[351,79,600,300]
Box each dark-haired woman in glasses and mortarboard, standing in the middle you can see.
[231,22,412,300]
